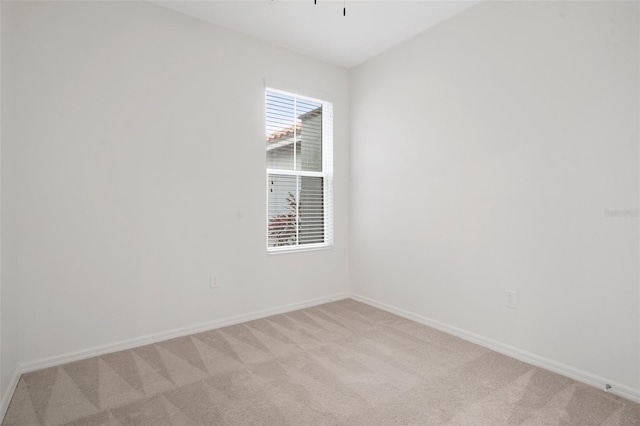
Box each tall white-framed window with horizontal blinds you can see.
[266,89,333,252]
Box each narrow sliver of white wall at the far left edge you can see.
[0,2,19,416]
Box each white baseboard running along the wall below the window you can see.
[19,292,349,374]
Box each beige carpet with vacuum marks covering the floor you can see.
[3,300,640,426]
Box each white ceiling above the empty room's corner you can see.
[154,0,478,68]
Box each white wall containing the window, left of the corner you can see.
[7,2,349,362]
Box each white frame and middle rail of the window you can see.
[264,87,333,254]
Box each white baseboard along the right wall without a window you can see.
[350,293,640,402]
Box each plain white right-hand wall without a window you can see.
[351,2,640,392]
